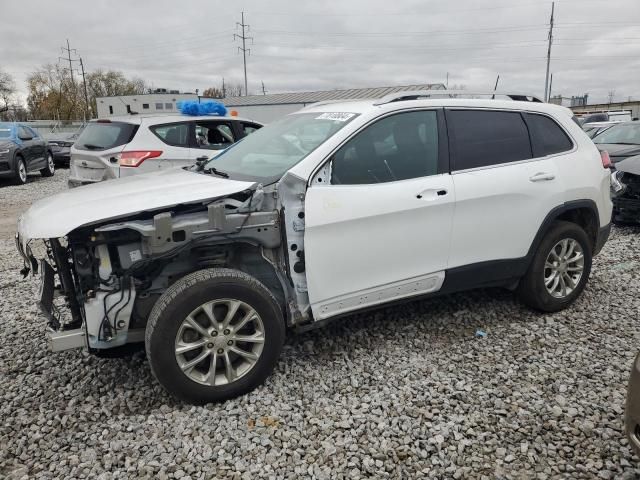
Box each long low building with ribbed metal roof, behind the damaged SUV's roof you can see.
[220,83,445,123]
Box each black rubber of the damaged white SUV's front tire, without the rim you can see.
[145,268,285,404]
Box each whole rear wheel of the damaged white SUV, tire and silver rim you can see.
[518,221,592,312]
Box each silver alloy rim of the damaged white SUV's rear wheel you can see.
[544,238,584,298]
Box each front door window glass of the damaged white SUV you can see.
[331,110,438,185]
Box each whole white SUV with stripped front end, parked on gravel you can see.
[17,91,612,403]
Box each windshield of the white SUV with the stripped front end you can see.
[204,112,357,183]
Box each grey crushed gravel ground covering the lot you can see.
[0,171,640,479]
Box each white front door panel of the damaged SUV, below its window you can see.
[304,174,455,319]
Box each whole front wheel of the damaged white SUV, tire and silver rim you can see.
[145,268,285,403]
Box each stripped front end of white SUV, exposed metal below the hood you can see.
[16,175,309,352]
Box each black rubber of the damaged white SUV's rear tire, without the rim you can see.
[516,221,593,312]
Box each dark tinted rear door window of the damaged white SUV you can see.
[447,110,533,170]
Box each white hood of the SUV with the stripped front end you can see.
[18,168,255,243]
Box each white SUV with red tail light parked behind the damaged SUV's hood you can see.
[69,115,262,187]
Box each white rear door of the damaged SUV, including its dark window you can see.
[447,109,564,272]
